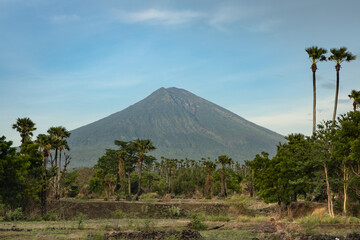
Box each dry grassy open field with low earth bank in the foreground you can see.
[0,198,360,240]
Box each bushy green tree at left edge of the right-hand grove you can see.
[249,134,311,218]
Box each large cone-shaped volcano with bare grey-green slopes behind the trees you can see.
[68,87,284,167]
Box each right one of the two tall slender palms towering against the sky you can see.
[329,47,356,126]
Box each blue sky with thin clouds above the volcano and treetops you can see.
[0,0,360,145]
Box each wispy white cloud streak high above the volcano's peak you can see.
[117,8,203,25]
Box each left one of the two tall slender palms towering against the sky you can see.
[305,46,327,134]
